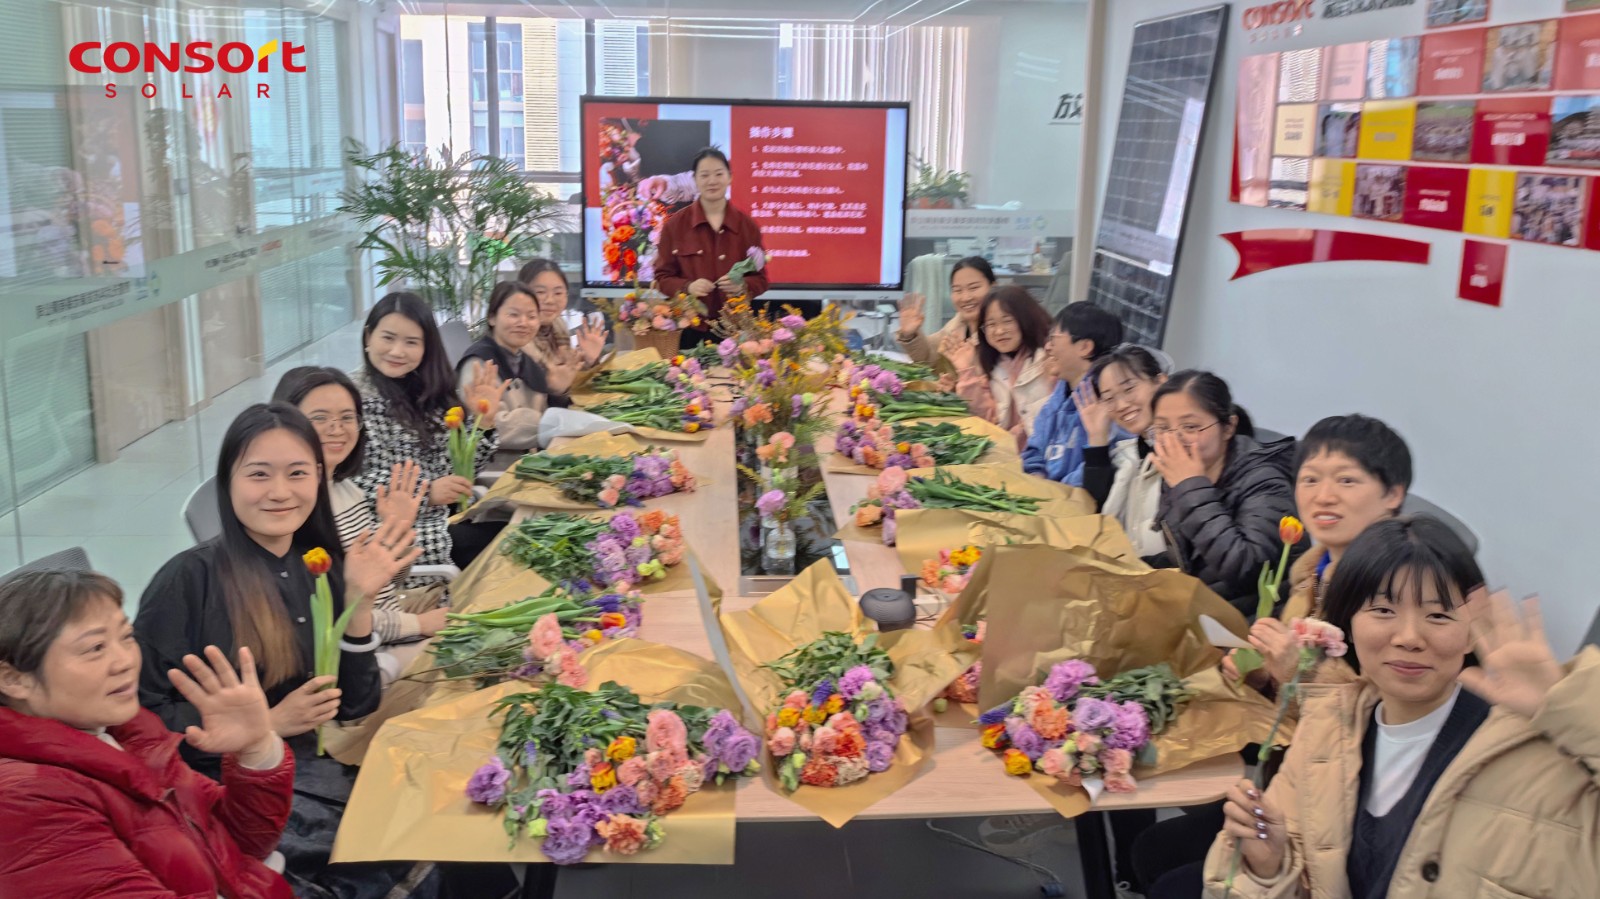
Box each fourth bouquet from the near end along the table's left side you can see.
[512,450,694,509]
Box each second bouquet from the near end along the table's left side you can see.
[430,587,642,686]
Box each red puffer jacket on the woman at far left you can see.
[0,707,294,899]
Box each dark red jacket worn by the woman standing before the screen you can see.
[656,200,768,318]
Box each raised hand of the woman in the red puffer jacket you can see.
[166,646,278,765]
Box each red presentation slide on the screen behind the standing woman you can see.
[582,98,907,290]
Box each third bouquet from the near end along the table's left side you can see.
[501,510,686,592]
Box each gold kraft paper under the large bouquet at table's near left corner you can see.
[333,640,739,865]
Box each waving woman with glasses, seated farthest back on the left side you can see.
[518,259,606,375]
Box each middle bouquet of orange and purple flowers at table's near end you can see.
[765,630,909,792]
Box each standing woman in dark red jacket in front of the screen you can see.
[654,147,768,347]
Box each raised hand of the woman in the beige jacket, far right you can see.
[1461,587,1562,718]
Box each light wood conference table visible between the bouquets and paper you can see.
[499,424,1243,899]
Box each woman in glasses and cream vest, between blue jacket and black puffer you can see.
[1072,344,1173,558]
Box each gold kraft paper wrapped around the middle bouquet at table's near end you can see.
[718,561,978,827]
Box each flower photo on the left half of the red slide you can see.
[598,118,710,283]
